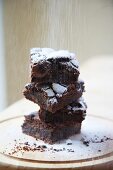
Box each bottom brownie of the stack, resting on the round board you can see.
[22,114,81,144]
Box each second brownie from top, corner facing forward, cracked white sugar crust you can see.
[23,81,84,113]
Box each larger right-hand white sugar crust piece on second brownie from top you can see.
[52,83,67,94]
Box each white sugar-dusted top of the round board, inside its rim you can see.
[0,115,113,161]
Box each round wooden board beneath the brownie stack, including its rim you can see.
[0,111,113,170]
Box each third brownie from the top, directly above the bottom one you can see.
[36,98,87,123]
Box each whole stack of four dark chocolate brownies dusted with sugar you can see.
[22,48,87,143]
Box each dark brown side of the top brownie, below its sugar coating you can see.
[31,60,79,84]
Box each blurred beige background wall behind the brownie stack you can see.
[0,0,113,110]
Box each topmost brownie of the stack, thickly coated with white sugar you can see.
[31,48,79,84]
